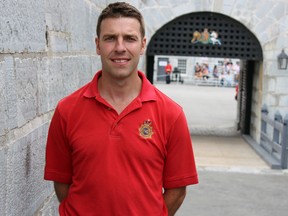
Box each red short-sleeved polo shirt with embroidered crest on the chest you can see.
[44,71,198,216]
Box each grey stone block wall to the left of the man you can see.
[0,0,100,216]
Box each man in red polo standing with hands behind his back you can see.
[44,3,198,216]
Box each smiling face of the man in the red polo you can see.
[96,17,146,79]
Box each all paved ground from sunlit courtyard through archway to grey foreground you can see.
[155,83,288,216]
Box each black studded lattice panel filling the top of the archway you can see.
[146,12,263,60]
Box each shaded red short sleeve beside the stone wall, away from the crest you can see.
[44,107,72,184]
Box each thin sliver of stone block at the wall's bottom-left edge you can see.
[0,148,7,215]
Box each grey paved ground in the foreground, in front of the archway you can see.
[176,170,288,216]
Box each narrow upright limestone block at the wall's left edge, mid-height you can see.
[4,56,18,129]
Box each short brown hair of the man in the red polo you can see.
[96,2,145,37]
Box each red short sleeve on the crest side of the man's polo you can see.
[163,110,198,188]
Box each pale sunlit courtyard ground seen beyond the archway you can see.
[155,83,237,135]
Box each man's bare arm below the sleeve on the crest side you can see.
[163,187,186,216]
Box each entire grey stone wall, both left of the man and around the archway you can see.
[0,0,288,216]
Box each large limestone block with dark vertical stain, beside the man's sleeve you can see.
[6,124,48,215]
